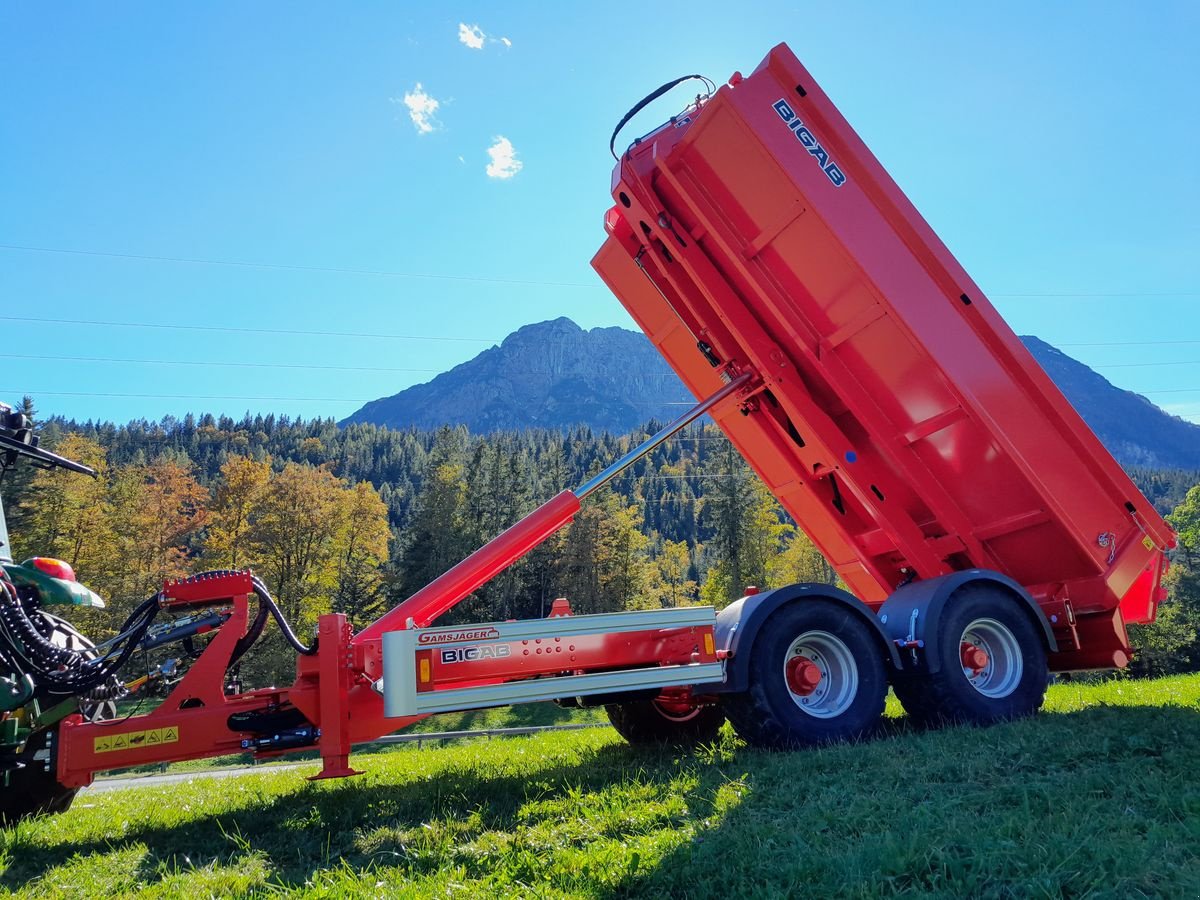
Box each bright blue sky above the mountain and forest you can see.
[0,1,1200,421]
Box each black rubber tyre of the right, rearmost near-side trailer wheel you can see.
[892,584,1049,725]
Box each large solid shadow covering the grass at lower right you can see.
[599,706,1200,898]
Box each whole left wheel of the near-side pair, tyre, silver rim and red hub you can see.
[724,600,888,749]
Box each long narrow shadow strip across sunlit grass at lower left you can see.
[0,744,667,889]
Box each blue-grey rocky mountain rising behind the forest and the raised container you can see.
[342,318,1200,469]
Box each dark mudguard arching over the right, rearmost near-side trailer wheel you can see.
[873,569,1058,672]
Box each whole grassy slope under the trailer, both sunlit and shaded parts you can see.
[0,676,1200,898]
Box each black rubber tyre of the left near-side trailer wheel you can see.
[722,600,888,750]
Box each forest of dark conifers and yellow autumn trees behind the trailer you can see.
[7,400,1200,680]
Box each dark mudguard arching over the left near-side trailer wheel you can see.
[704,584,901,694]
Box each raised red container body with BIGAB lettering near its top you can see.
[593,44,1175,670]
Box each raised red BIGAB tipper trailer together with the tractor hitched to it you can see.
[0,46,1175,822]
